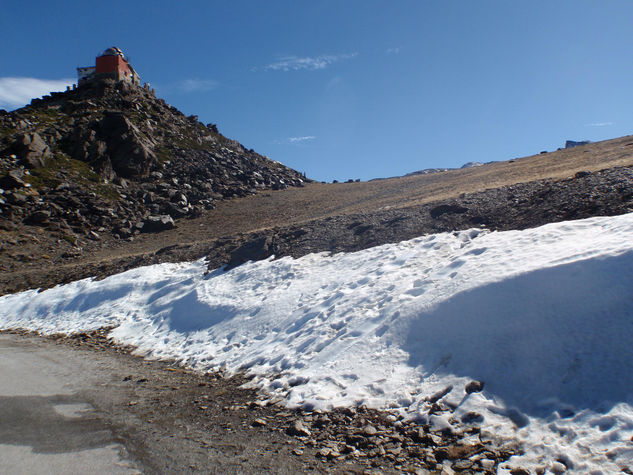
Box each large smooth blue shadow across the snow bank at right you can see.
[404,252,633,416]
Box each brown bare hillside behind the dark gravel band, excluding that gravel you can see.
[0,132,633,293]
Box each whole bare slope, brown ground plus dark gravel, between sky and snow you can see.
[0,154,633,293]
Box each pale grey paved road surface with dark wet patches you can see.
[0,335,139,474]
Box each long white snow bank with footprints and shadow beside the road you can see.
[0,214,633,473]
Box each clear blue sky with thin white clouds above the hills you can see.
[0,0,633,181]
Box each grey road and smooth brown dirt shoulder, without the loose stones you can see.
[0,334,317,475]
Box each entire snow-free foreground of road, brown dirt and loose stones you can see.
[0,329,517,475]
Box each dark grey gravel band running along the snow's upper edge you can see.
[207,167,633,270]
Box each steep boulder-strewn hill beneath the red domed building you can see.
[0,79,308,241]
